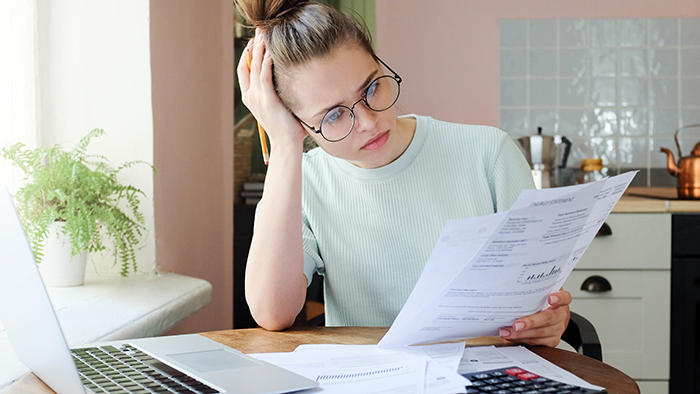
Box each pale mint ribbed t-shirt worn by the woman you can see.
[302,115,534,326]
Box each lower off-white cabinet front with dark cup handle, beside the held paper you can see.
[564,269,671,380]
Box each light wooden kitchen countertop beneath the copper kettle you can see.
[613,187,700,213]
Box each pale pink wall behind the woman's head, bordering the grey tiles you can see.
[375,0,700,126]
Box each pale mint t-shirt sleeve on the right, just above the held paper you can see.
[489,133,535,212]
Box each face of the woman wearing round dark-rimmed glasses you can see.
[291,44,413,168]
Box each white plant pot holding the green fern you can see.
[39,222,87,287]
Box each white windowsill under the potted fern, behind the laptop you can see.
[0,274,212,392]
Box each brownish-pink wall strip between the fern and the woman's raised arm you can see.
[149,0,234,334]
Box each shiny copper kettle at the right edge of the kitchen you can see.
[661,124,700,199]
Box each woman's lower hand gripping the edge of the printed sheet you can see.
[500,289,571,347]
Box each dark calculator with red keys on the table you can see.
[462,367,607,394]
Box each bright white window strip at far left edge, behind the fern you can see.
[0,0,38,192]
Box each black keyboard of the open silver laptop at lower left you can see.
[71,344,219,394]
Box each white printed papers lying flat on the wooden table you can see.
[252,342,603,394]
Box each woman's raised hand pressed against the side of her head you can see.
[237,29,307,148]
